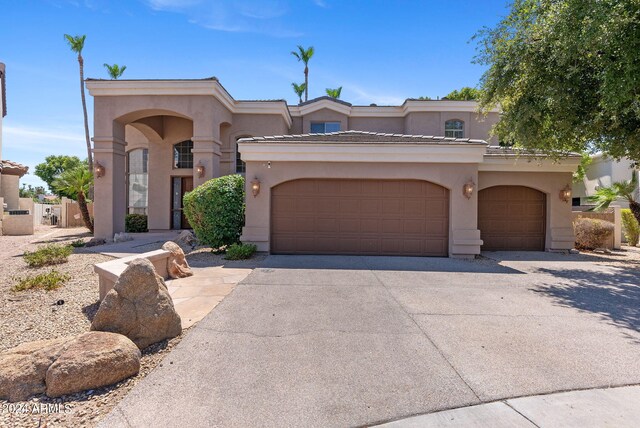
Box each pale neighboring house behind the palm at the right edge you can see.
[572,153,640,208]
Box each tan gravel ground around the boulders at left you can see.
[0,227,190,427]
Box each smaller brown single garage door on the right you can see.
[478,186,546,251]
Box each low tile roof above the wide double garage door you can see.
[238,131,487,145]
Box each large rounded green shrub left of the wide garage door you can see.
[184,174,244,248]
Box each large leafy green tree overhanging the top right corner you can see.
[475,0,640,162]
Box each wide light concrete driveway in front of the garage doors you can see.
[102,253,640,427]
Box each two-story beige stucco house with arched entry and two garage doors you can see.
[86,78,580,257]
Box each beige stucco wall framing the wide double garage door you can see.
[241,162,481,256]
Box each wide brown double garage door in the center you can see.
[271,179,449,256]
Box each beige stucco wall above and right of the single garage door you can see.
[477,171,574,250]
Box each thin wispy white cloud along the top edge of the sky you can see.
[144,0,302,37]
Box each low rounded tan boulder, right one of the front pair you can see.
[46,331,141,397]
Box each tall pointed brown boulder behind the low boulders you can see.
[91,259,182,349]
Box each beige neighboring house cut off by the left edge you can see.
[0,62,29,212]
